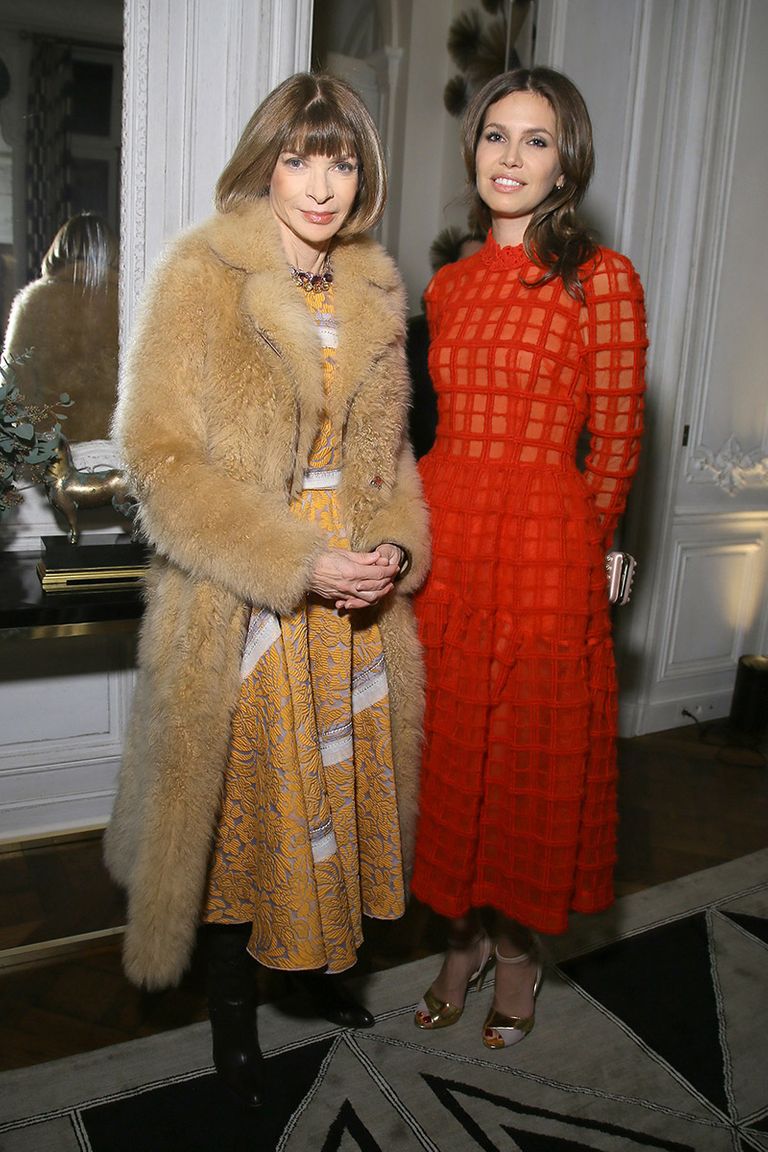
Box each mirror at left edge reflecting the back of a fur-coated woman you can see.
[0,0,122,441]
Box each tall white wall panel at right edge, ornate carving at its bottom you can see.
[678,3,768,507]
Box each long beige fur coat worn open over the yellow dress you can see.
[106,200,428,987]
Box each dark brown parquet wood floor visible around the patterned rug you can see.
[0,725,768,1069]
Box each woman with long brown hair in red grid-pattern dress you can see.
[412,68,647,1048]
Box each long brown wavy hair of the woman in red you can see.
[462,68,598,300]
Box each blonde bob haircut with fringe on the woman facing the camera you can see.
[215,73,387,237]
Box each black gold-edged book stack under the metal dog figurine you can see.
[37,533,151,592]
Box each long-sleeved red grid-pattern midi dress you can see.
[412,234,647,932]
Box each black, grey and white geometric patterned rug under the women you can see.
[0,850,768,1152]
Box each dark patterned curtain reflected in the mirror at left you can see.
[26,40,73,280]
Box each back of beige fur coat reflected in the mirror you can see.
[3,267,117,441]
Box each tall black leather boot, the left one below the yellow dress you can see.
[204,924,264,1108]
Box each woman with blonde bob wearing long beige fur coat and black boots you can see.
[106,74,427,1105]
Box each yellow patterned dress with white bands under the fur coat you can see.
[203,278,404,972]
